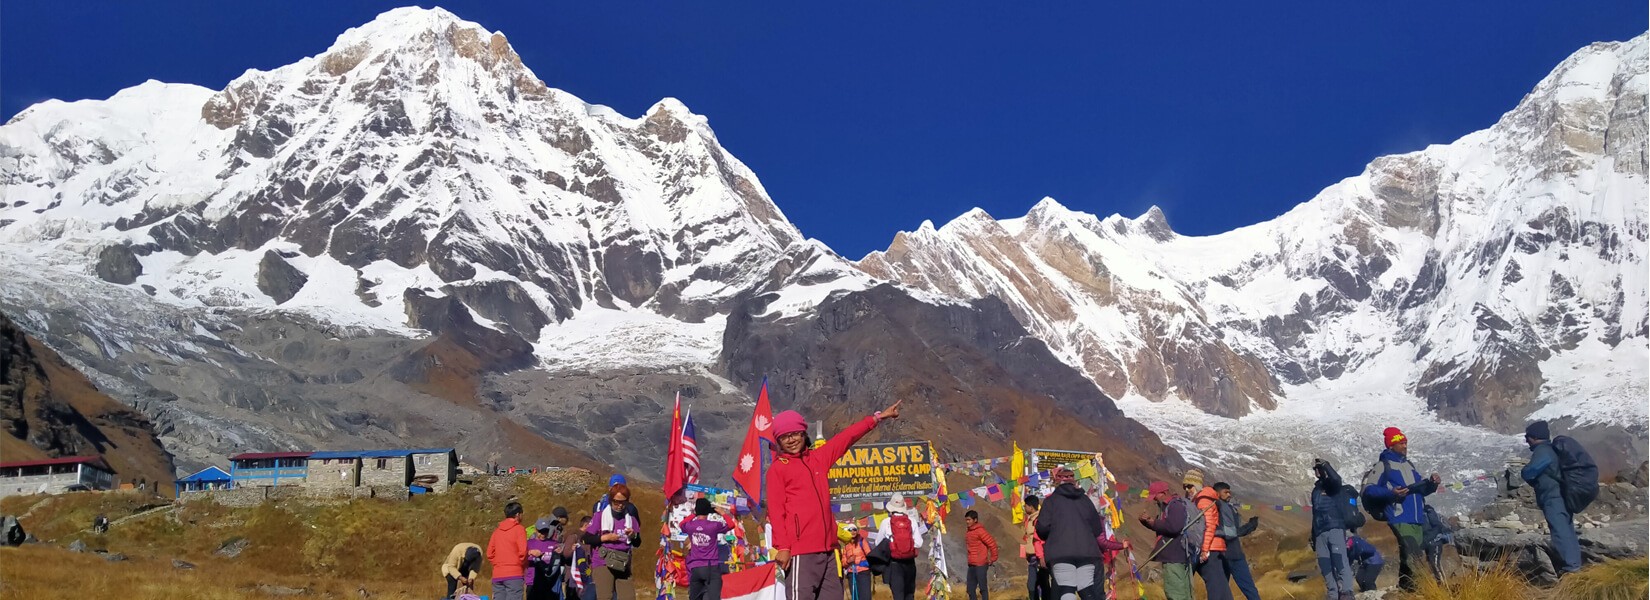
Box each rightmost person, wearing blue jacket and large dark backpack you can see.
[1520,420,1599,577]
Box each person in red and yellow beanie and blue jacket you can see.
[1363,427,1440,592]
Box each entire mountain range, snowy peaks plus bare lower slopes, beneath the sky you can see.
[0,8,1650,497]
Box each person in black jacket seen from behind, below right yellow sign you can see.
[1036,466,1106,600]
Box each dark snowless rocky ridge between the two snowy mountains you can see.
[721,284,1185,480]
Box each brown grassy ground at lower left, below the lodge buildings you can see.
[0,470,663,598]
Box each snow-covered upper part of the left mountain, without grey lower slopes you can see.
[0,8,871,354]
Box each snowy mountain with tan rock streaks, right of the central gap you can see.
[858,36,1650,468]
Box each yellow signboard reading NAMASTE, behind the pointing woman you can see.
[828,442,934,503]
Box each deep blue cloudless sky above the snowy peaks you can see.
[0,0,1650,259]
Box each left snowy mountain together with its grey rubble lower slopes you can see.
[0,8,871,468]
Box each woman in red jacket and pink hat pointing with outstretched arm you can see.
[767,402,899,600]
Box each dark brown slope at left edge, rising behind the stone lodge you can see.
[0,309,173,495]
